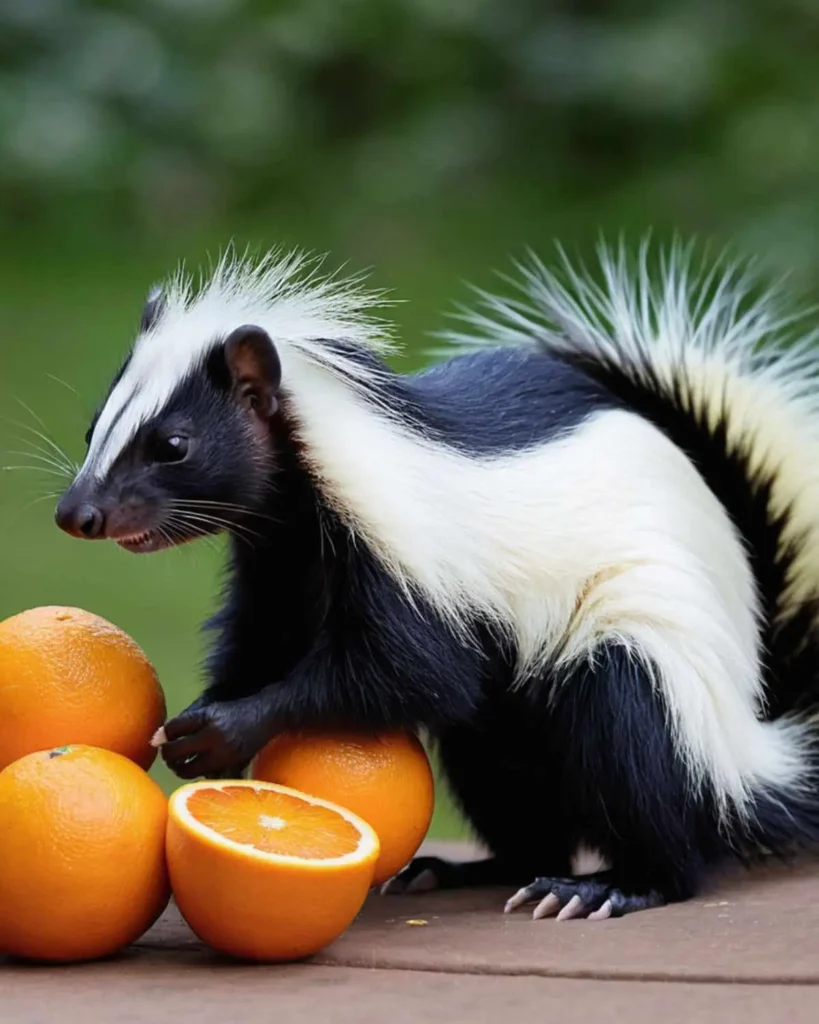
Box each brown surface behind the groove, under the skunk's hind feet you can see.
[318,847,819,983]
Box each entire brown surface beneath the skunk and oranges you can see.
[0,847,819,1024]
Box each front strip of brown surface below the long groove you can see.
[6,963,817,1024]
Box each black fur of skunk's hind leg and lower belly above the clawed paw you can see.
[393,644,730,912]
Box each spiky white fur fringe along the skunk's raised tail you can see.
[448,238,819,616]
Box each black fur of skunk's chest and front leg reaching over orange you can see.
[163,434,480,777]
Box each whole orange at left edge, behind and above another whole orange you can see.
[0,606,166,769]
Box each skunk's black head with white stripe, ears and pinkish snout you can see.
[55,292,282,552]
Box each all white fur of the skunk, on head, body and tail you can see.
[76,237,819,812]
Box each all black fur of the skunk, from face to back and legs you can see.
[59,311,819,914]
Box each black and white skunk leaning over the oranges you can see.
[56,237,819,920]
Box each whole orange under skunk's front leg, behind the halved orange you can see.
[250,731,435,885]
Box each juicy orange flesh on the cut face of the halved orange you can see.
[187,785,361,860]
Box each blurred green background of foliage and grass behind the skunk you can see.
[0,0,819,835]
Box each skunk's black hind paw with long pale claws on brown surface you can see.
[504,872,665,921]
